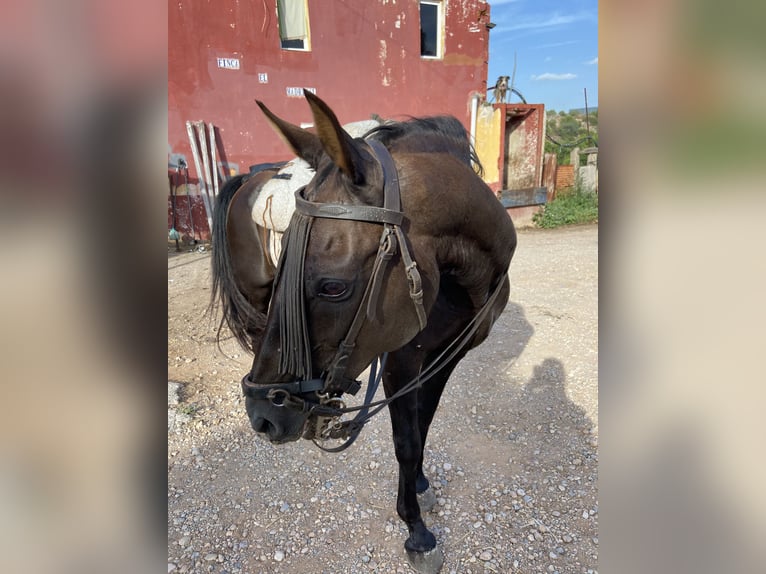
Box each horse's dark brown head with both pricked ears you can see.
[249,93,433,442]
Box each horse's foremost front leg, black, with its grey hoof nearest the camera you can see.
[385,379,444,574]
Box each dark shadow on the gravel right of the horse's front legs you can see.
[414,302,598,571]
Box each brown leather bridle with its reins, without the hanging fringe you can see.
[242,140,507,452]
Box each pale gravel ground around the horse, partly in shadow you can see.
[168,225,598,574]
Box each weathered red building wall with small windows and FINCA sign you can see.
[168,0,489,181]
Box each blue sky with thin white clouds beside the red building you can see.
[488,0,598,111]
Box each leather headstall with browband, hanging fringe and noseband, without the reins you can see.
[242,140,426,450]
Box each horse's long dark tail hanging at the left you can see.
[208,174,262,350]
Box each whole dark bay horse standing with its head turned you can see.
[213,92,516,572]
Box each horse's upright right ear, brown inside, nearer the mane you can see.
[303,90,365,184]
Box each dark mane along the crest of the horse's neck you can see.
[364,116,484,175]
